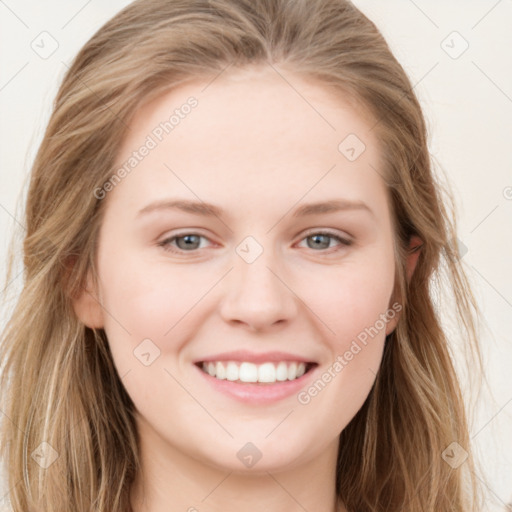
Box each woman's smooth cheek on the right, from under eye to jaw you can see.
[299,255,398,408]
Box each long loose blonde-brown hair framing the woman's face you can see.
[0,0,481,512]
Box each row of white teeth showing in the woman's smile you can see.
[202,361,306,383]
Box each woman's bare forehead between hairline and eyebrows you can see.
[108,66,384,216]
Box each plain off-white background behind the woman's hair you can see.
[0,0,512,511]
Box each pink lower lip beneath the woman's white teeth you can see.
[194,365,318,404]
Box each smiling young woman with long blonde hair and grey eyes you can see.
[2,0,486,512]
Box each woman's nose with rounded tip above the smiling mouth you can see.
[220,251,299,331]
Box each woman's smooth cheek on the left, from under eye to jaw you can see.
[95,258,212,412]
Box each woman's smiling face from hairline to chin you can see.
[75,69,412,471]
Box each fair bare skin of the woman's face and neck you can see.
[74,67,418,512]
